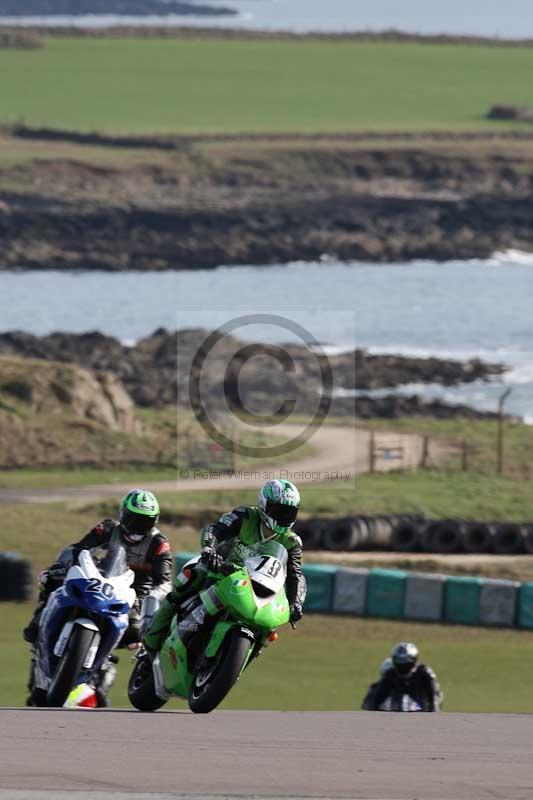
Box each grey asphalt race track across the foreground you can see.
[0,701,533,800]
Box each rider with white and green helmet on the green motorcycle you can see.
[144,480,306,652]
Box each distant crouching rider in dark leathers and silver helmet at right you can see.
[362,642,444,711]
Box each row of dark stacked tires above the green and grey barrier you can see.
[295,514,533,555]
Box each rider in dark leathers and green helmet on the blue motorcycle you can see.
[23,489,172,705]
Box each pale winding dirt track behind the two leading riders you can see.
[0,424,428,503]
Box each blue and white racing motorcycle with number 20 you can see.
[34,539,136,706]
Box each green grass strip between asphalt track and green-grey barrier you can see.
[4,603,533,713]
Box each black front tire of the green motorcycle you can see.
[189,629,252,714]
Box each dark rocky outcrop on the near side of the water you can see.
[0,329,505,419]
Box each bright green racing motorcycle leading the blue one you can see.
[128,540,289,714]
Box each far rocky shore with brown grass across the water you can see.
[0,129,533,271]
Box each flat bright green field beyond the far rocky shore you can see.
[0,38,533,133]
